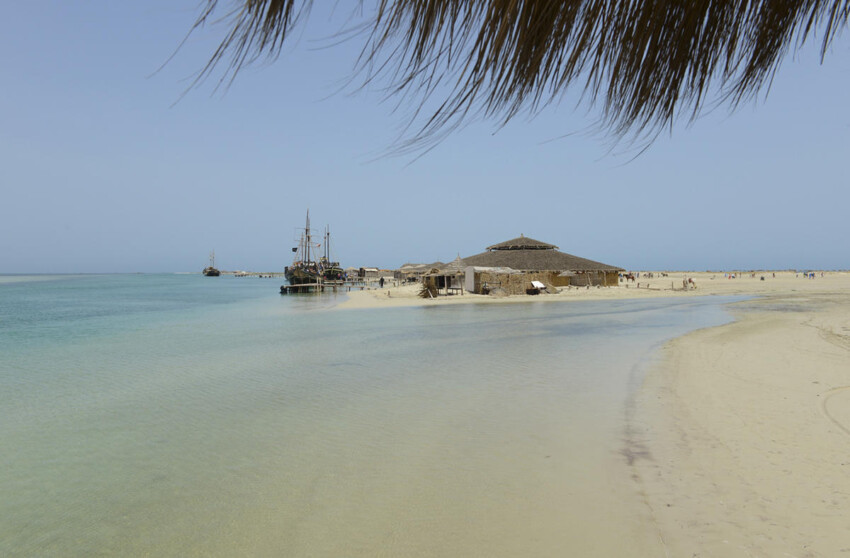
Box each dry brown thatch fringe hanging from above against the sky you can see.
[189,0,850,151]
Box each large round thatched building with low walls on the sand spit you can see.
[463,235,623,294]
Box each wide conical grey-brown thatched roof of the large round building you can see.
[463,236,623,271]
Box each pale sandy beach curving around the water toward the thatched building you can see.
[342,272,850,557]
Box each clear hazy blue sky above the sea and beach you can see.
[0,0,850,273]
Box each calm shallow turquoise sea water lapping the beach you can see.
[0,275,730,557]
